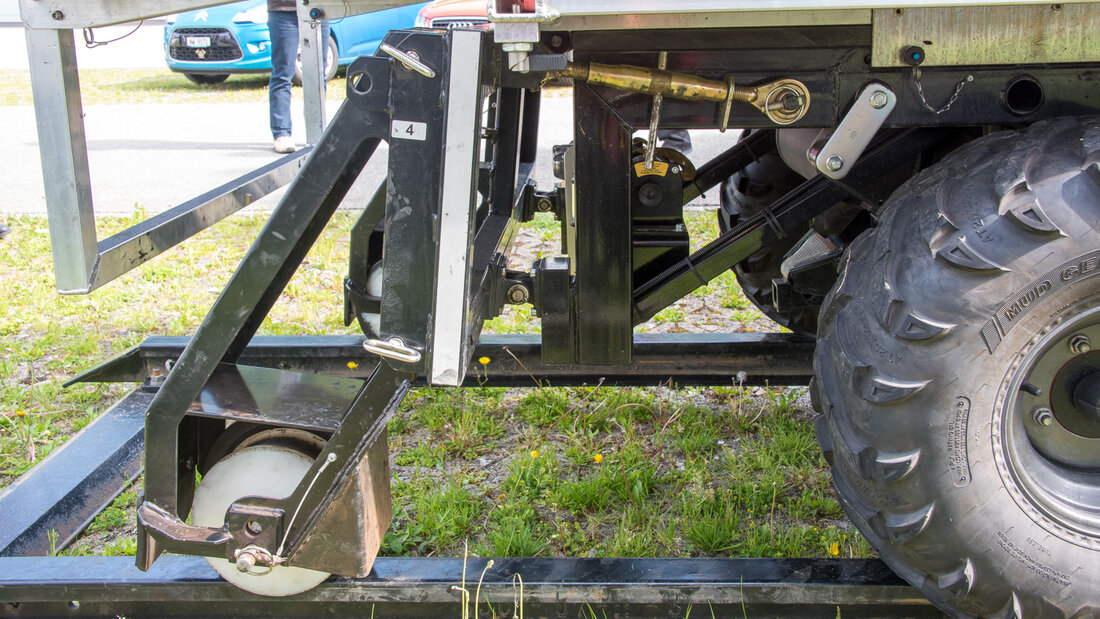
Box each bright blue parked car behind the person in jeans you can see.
[164,0,427,85]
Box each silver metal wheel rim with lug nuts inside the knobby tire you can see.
[994,307,1100,543]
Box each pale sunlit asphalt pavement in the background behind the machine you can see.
[8,24,736,214]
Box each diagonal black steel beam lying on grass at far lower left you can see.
[0,391,153,556]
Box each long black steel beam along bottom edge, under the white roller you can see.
[0,556,942,619]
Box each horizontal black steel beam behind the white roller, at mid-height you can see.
[70,333,815,387]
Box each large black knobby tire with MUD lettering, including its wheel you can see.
[813,119,1100,617]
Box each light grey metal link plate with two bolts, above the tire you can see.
[806,82,898,178]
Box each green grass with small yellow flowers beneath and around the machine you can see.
[0,206,871,557]
